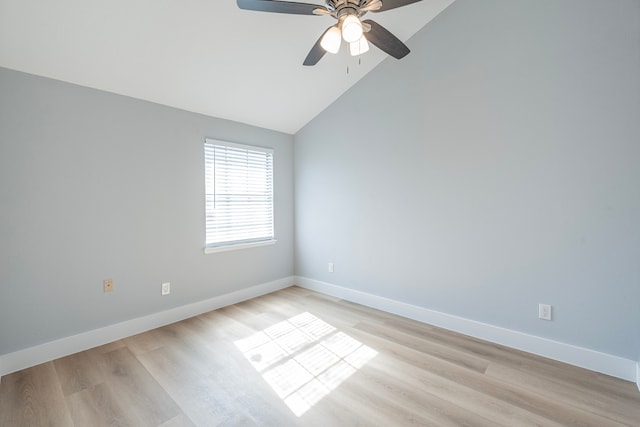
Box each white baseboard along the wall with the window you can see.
[0,276,294,379]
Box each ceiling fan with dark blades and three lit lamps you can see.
[237,0,421,65]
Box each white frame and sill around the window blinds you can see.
[203,138,277,254]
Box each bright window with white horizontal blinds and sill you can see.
[204,139,275,253]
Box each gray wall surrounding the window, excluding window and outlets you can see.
[0,69,293,354]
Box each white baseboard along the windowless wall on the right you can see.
[296,276,640,388]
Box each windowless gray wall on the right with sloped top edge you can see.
[294,0,640,360]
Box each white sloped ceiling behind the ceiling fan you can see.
[0,0,454,134]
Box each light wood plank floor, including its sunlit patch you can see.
[0,287,640,427]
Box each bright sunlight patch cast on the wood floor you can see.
[235,312,377,416]
